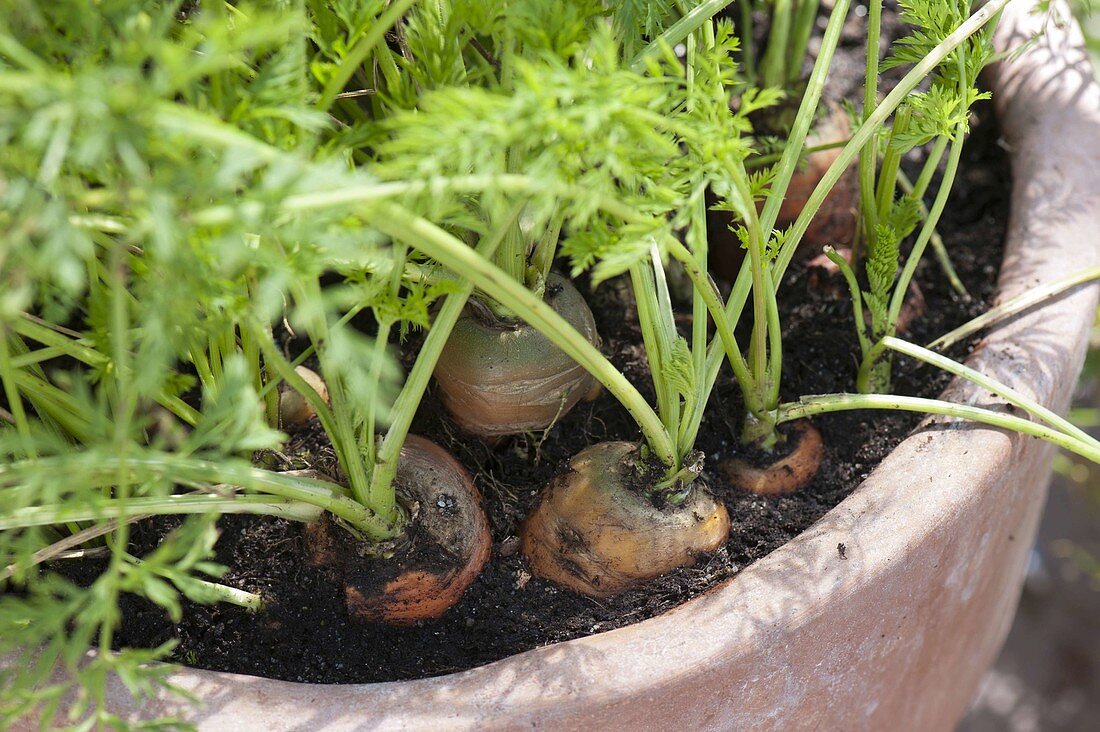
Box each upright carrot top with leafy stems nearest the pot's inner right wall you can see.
[826,0,993,393]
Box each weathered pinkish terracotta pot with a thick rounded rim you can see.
[23,0,1100,730]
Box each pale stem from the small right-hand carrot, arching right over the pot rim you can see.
[777,394,1100,462]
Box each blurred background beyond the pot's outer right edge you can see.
[959,8,1100,732]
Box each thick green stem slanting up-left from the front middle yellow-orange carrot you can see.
[372,204,677,466]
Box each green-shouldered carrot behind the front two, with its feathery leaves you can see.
[340,2,642,437]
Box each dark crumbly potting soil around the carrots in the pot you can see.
[62,12,1009,682]
